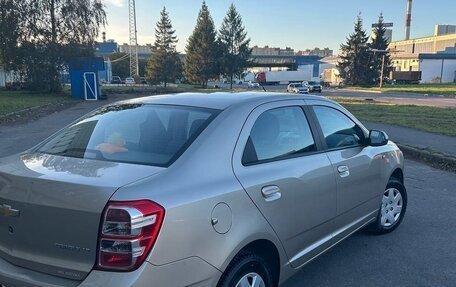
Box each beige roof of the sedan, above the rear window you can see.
[121,92,333,110]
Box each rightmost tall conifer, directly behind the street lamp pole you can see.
[369,14,392,83]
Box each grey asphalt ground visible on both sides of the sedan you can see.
[0,99,456,287]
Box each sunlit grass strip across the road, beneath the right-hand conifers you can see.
[347,84,456,97]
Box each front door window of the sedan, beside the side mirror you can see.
[313,106,364,149]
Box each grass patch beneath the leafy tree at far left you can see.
[0,90,73,117]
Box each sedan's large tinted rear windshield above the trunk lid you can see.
[34,104,220,167]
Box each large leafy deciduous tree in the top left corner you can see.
[0,0,106,92]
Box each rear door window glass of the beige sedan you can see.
[242,107,316,165]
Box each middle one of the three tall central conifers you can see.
[184,2,219,88]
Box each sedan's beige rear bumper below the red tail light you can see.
[0,257,222,287]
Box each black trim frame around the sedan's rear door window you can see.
[240,106,324,167]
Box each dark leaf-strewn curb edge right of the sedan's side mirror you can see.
[396,143,456,173]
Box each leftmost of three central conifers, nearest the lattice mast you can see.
[146,7,182,87]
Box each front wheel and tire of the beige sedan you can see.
[368,178,407,234]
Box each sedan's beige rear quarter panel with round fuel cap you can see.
[112,105,286,276]
